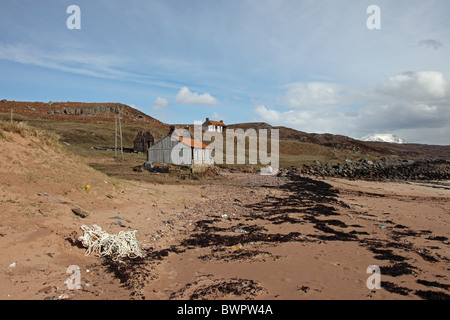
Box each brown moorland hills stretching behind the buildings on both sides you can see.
[0,100,450,166]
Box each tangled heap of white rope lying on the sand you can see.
[78,224,144,261]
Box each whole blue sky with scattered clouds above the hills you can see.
[0,0,450,145]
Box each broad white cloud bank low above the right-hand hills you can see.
[253,71,450,144]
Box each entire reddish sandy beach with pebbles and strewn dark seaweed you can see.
[0,165,450,300]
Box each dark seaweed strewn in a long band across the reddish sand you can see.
[99,176,449,300]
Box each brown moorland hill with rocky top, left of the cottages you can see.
[0,100,170,157]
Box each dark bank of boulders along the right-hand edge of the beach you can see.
[297,158,450,181]
